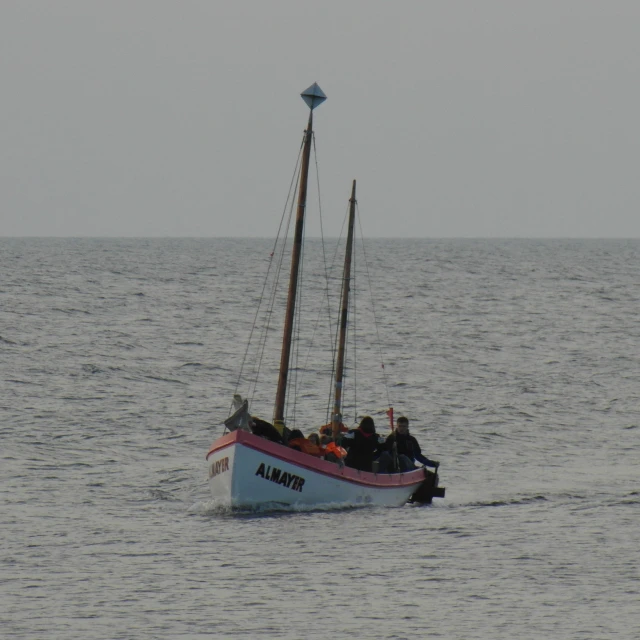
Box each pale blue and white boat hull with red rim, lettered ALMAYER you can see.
[207,430,437,508]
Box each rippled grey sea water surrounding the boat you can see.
[0,239,640,640]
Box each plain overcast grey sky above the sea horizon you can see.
[0,0,640,237]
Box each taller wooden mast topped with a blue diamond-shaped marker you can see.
[273,82,327,422]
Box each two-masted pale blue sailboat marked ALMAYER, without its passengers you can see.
[206,83,445,509]
